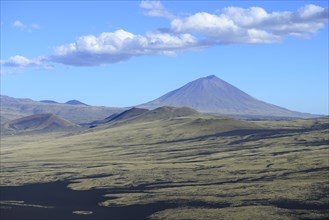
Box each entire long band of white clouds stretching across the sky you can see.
[1,1,329,67]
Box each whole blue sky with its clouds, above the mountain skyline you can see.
[1,1,329,114]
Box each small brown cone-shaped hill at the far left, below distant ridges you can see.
[4,114,77,131]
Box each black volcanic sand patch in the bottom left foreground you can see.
[0,182,177,220]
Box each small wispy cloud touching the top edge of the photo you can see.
[139,1,174,19]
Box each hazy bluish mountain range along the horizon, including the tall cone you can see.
[0,75,318,126]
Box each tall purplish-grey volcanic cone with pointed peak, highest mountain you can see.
[138,75,311,117]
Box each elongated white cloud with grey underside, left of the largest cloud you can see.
[49,30,197,66]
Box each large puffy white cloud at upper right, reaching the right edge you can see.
[171,5,328,44]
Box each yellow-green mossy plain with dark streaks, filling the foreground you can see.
[0,114,329,219]
